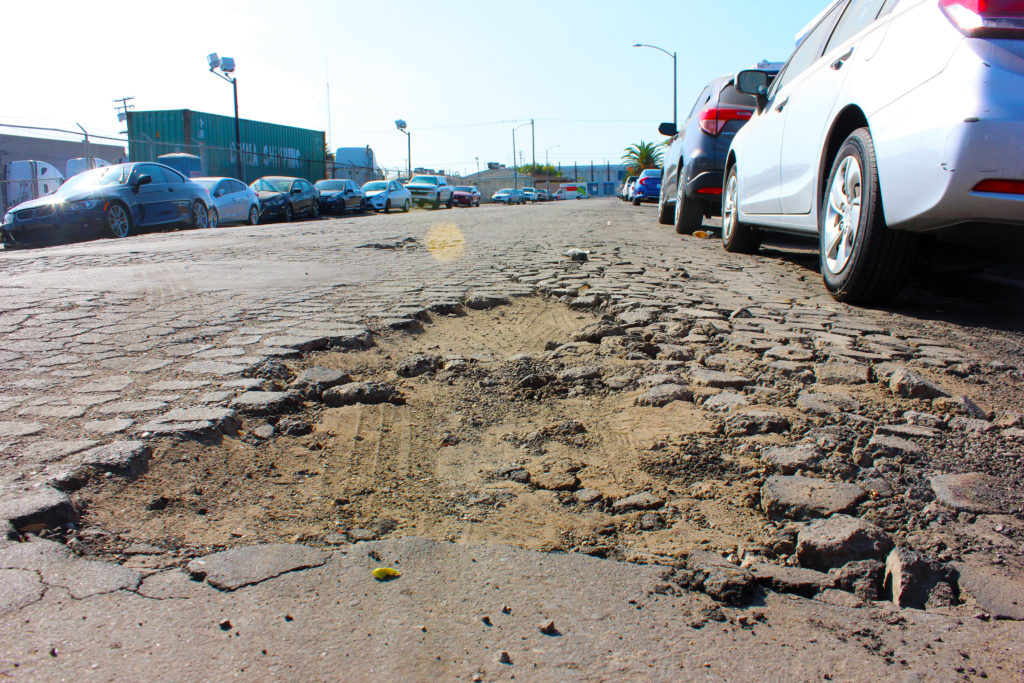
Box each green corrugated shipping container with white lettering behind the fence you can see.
[128,110,327,183]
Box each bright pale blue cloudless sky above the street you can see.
[0,0,825,172]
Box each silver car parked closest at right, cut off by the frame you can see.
[722,0,1024,303]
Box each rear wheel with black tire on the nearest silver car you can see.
[818,128,920,304]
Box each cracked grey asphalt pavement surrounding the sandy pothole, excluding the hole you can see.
[0,200,1024,680]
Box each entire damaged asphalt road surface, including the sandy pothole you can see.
[0,201,1024,680]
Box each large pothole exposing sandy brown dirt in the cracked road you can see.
[80,298,763,569]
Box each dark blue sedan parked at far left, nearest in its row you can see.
[2,163,210,248]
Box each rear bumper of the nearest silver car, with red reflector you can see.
[869,39,1024,233]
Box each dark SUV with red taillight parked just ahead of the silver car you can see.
[657,67,778,234]
